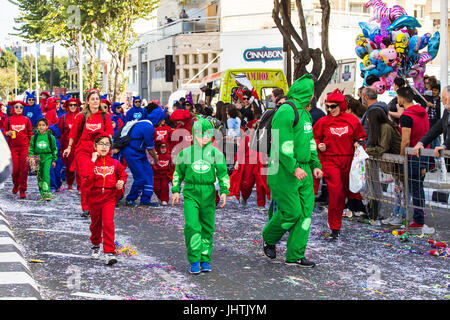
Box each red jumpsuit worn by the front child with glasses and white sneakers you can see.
[83,155,128,254]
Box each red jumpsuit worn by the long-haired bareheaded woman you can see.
[69,111,114,211]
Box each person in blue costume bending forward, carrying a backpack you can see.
[116,119,158,207]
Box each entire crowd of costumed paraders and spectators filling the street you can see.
[0,75,450,274]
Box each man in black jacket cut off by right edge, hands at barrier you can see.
[413,86,450,158]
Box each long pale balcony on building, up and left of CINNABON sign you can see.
[135,17,220,47]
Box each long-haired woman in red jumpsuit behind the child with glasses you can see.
[63,90,114,217]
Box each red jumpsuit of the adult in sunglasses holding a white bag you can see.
[313,112,367,230]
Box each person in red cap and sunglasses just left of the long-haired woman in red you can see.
[58,99,81,190]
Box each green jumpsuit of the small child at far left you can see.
[28,131,58,198]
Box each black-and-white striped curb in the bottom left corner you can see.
[0,209,42,300]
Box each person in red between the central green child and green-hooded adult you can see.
[229,120,270,210]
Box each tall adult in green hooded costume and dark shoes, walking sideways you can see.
[262,74,322,267]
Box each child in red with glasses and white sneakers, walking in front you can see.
[83,134,128,265]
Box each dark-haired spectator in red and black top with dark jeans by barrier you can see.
[397,87,429,232]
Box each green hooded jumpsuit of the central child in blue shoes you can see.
[172,118,230,264]
